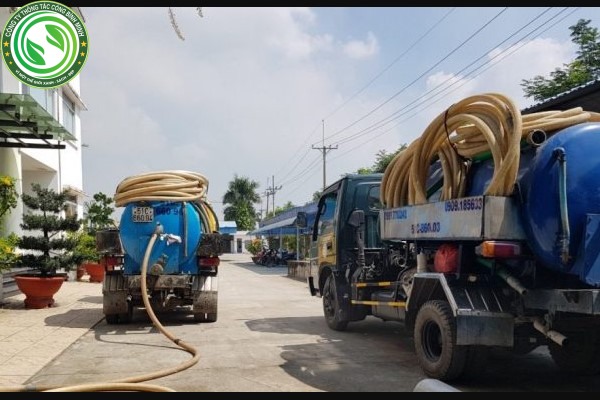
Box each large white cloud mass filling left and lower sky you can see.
[76,7,584,222]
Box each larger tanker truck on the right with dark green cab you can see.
[308,97,600,381]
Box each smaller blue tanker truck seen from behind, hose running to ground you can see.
[96,170,222,324]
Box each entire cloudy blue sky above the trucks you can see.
[81,7,600,222]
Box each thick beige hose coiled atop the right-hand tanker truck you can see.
[380,93,600,207]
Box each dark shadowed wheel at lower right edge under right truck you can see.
[548,332,600,376]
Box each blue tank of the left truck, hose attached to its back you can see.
[119,201,202,275]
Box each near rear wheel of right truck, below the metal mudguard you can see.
[414,300,468,381]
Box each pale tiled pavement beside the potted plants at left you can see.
[0,275,104,391]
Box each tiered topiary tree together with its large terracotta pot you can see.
[15,183,81,308]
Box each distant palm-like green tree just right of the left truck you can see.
[223,174,260,230]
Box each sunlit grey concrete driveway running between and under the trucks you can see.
[12,254,600,392]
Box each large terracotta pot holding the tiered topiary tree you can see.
[14,274,65,308]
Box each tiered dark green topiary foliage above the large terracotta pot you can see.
[18,183,82,277]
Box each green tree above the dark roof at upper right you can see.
[521,19,600,101]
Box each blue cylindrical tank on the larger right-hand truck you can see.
[467,122,600,286]
